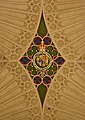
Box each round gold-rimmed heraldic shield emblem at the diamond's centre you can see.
[33,51,52,71]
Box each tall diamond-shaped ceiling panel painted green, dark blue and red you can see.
[20,15,65,105]
